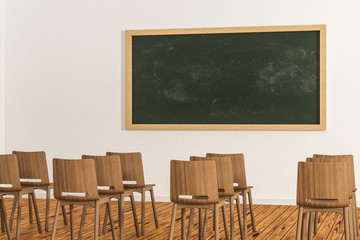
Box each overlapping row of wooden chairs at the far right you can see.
[296,154,359,240]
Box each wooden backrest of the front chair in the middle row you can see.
[170,160,219,204]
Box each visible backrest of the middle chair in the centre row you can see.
[190,156,234,197]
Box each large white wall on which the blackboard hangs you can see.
[5,0,360,203]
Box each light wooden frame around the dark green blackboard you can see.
[125,25,326,131]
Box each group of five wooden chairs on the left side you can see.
[0,151,159,239]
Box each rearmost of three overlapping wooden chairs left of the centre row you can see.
[106,152,159,235]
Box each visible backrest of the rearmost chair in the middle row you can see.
[206,153,247,190]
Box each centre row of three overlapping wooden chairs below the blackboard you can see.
[169,153,256,239]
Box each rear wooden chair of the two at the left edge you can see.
[10,151,67,232]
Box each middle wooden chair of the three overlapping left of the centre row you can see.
[82,155,140,239]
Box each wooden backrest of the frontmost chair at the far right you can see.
[296,162,351,208]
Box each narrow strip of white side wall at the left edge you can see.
[0,0,5,152]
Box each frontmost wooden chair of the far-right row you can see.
[296,162,356,240]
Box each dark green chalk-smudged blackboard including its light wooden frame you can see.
[126,26,325,130]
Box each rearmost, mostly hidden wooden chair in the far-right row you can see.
[313,154,359,235]
